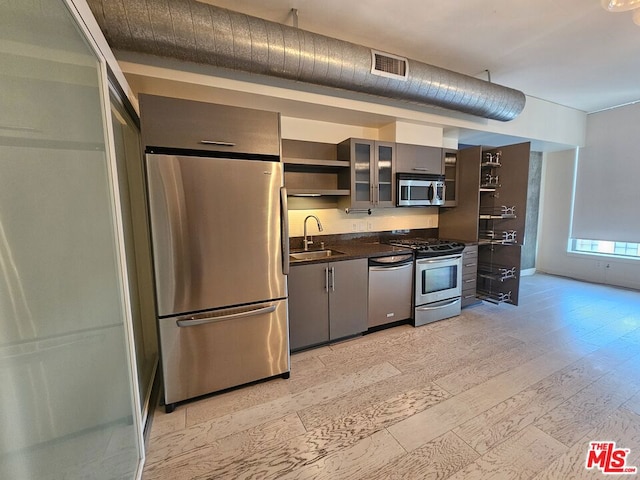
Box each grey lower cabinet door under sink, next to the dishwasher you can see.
[329,258,369,340]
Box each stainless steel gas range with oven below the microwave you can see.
[389,238,464,327]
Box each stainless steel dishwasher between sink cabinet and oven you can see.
[368,253,413,328]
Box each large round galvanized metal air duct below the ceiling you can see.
[88,0,525,121]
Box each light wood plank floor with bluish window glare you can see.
[143,274,640,480]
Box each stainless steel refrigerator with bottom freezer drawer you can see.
[146,154,289,412]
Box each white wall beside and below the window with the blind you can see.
[536,149,640,289]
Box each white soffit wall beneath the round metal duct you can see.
[116,51,586,150]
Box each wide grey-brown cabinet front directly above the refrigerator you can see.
[140,94,280,156]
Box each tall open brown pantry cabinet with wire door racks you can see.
[439,143,530,305]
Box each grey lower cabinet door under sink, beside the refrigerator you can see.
[288,263,329,350]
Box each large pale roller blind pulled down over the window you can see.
[567,104,640,242]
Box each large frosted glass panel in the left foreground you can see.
[0,0,141,480]
